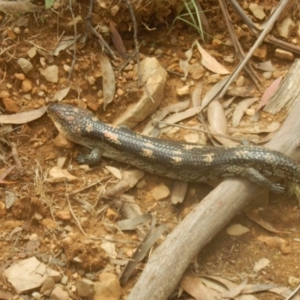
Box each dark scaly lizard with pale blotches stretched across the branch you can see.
[48,104,300,193]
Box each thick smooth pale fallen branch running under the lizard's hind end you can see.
[127,58,300,300]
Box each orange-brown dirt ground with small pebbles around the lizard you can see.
[0,1,300,300]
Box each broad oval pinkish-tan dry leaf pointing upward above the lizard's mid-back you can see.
[207,100,237,146]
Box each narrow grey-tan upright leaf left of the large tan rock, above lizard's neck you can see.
[101,54,116,110]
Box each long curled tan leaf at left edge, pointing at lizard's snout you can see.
[0,106,47,124]
